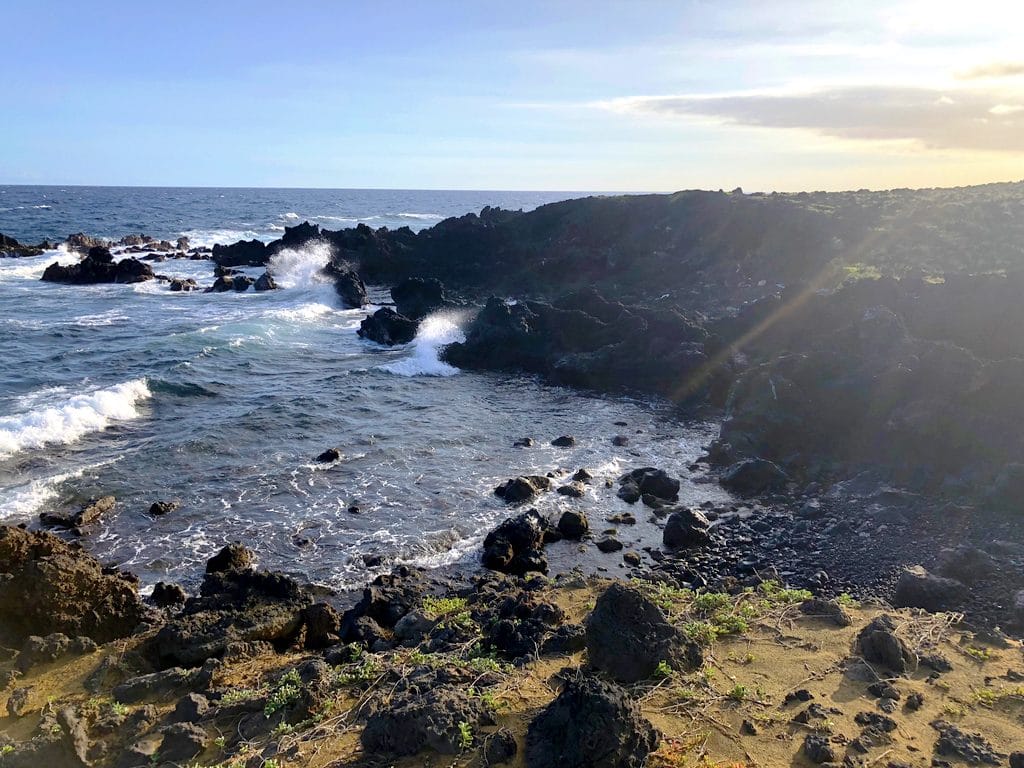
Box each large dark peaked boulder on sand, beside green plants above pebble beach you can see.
[586,583,702,683]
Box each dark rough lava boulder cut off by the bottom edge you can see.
[526,677,659,768]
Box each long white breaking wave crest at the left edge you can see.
[0,379,151,456]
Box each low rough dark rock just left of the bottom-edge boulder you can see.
[359,686,488,756]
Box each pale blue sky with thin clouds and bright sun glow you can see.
[0,0,1024,191]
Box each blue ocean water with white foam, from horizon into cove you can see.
[0,187,724,588]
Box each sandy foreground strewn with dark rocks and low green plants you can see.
[0,527,1024,768]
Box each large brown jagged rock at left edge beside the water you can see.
[0,526,143,647]
